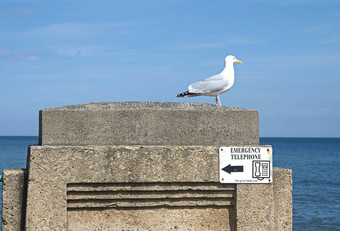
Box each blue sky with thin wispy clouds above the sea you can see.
[0,0,340,137]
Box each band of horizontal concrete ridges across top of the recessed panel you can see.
[67,182,235,210]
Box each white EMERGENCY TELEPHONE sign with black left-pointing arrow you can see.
[220,146,273,184]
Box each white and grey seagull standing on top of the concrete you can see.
[176,55,242,106]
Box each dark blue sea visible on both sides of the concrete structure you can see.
[0,136,340,231]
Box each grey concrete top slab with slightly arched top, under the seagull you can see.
[40,102,259,146]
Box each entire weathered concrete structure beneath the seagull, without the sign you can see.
[3,102,292,231]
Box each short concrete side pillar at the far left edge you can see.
[1,169,26,231]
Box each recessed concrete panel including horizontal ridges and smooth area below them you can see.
[67,182,236,231]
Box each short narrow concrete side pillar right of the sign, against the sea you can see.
[273,168,293,230]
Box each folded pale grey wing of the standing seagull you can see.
[188,79,229,94]
